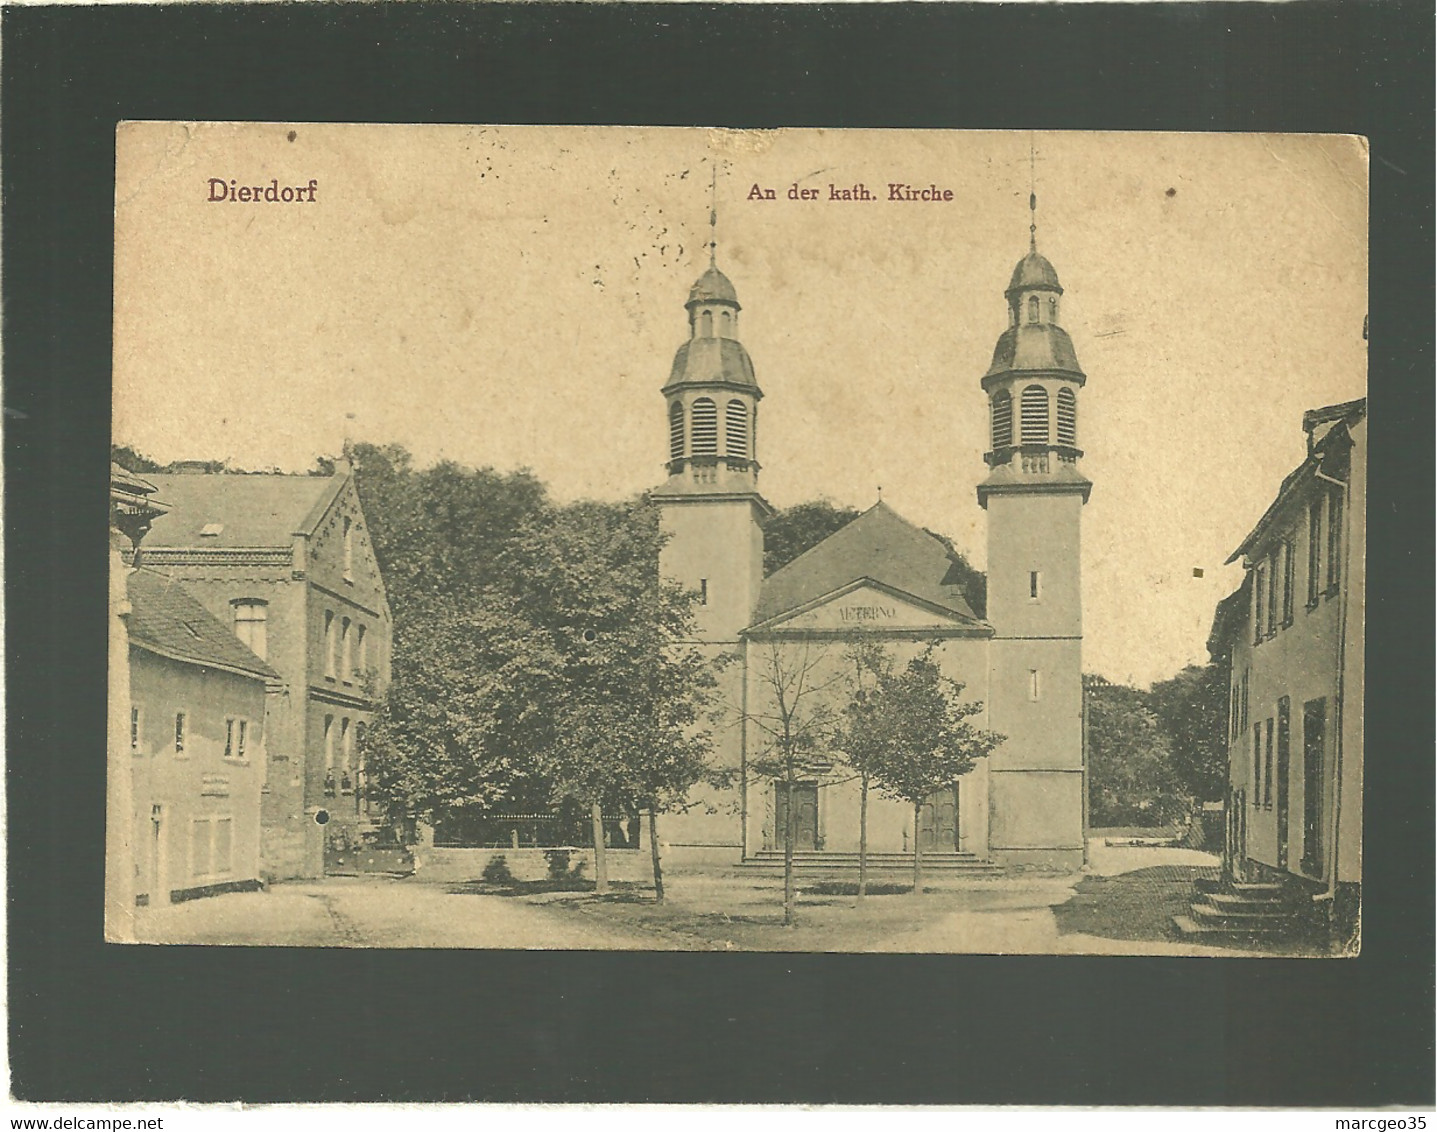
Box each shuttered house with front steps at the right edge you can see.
[1209,401,1367,919]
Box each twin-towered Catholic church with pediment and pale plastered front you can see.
[652,216,1091,869]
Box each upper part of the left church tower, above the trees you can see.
[651,259,772,646]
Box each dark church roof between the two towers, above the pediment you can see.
[753,503,984,625]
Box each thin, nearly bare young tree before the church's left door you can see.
[744,641,845,927]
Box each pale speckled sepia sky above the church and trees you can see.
[114,122,1368,685]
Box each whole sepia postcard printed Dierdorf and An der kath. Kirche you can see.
[106,122,1368,957]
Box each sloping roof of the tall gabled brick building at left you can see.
[145,474,348,549]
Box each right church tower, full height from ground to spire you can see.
[979,197,1092,866]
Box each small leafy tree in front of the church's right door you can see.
[856,646,1003,896]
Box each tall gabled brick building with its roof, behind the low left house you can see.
[144,470,392,879]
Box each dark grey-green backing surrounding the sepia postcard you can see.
[0,3,1434,1106]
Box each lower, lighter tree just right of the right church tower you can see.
[1083,675,1187,826]
